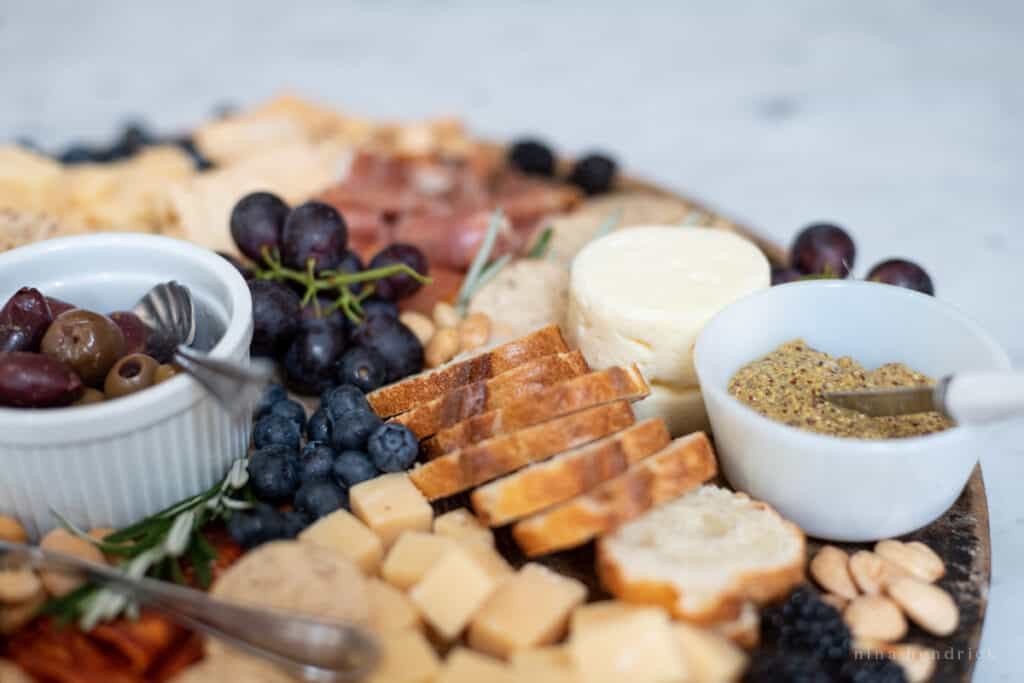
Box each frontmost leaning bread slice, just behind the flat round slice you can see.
[512,432,718,557]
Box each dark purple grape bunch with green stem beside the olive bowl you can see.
[227,193,428,395]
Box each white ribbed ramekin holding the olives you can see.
[0,233,253,537]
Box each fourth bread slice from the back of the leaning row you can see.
[409,400,634,501]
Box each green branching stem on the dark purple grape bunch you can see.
[255,247,432,325]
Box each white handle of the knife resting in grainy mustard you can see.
[935,372,1024,425]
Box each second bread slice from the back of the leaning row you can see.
[390,351,590,439]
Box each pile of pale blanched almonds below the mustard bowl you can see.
[810,539,959,683]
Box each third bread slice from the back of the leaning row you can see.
[421,365,649,459]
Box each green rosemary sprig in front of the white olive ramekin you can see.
[42,458,251,631]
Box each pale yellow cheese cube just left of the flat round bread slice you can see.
[469,563,587,657]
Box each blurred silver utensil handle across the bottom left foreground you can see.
[0,541,380,683]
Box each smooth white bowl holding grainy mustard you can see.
[694,281,1010,542]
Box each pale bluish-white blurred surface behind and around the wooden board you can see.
[0,0,1024,681]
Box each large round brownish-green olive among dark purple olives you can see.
[41,308,125,387]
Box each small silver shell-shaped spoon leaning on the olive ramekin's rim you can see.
[132,281,273,416]
